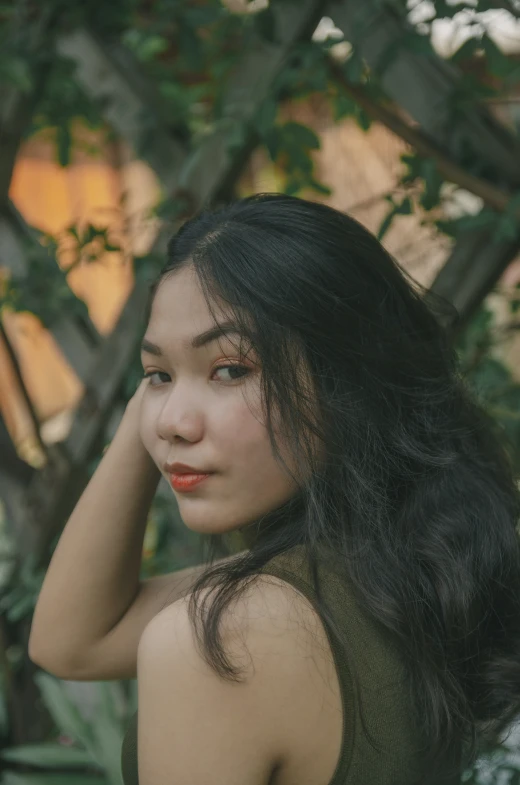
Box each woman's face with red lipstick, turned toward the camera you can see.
[141,267,297,534]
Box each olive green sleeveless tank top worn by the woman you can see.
[121,546,460,785]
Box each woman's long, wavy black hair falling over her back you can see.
[148,193,520,782]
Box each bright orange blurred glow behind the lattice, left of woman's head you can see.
[0,126,141,457]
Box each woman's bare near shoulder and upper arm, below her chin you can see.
[137,575,341,785]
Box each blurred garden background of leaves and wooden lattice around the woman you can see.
[0,0,520,785]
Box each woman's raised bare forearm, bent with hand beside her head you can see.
[29,386,160,675]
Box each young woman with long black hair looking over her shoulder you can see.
[31,194,520,785]
